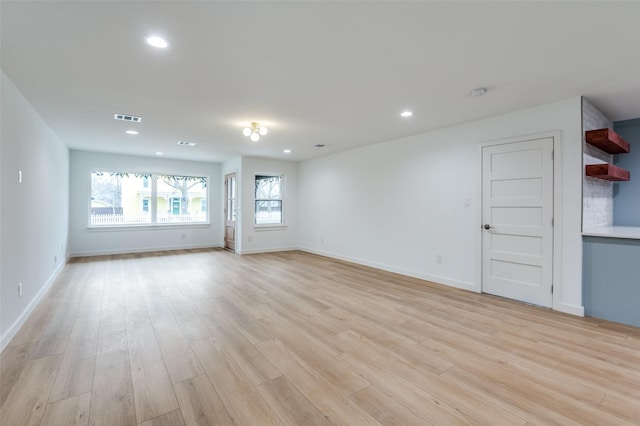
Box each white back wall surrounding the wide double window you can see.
[69,151,222,256]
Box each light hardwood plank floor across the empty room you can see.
[0,249,640,426]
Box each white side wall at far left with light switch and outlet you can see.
[0,73,69,350]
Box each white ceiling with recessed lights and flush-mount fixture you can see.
[0,0,640,161]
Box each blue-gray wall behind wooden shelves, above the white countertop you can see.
[613,118,640,226]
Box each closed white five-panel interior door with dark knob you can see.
[482,137,553,307]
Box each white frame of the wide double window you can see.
[87,167,211,231]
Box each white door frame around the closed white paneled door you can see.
[476,130,563,310]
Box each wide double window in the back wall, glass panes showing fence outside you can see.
[89,171,209,226]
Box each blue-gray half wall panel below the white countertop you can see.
[582,236,640,327]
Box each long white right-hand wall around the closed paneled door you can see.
[298,97,583,315]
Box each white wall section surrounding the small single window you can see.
[236,157,298,254]
